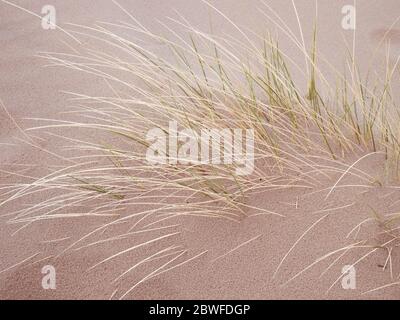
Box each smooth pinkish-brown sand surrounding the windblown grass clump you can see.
[0,0,400,299]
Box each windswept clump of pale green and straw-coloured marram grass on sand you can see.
[1,1,400,297]
